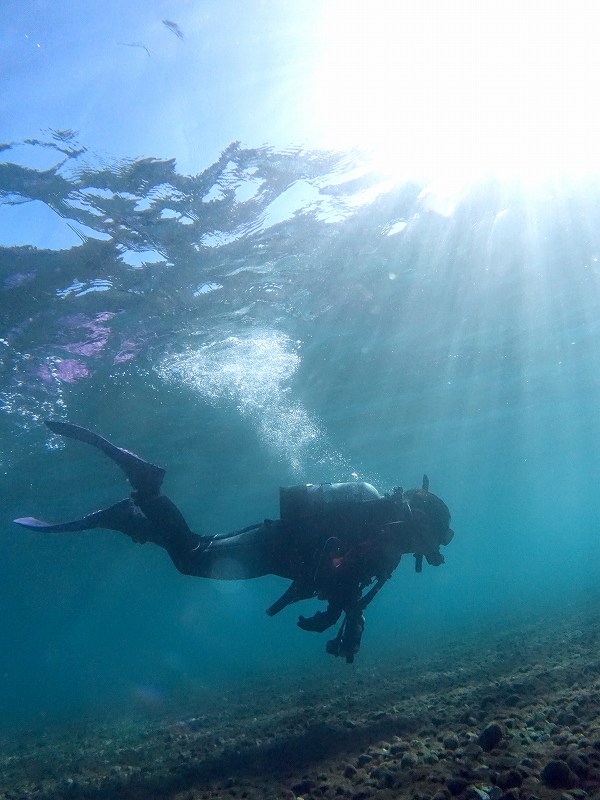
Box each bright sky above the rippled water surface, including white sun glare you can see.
[0,0,600,206]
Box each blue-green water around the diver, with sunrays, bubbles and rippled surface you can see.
[0,133,600,728]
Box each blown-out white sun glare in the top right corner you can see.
[313,0,600,183]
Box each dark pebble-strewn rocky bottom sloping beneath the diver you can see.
[0,609,600,800]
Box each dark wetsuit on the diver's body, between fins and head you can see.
[95,483,426,663]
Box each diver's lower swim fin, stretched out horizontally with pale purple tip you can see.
[13,498,157,542]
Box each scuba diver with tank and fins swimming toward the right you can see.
[14,421,454,663]
